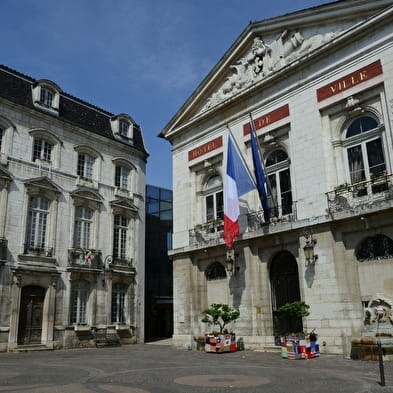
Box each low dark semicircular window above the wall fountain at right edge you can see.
[356,235,393,262]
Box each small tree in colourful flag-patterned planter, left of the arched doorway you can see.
[201,303,240,353]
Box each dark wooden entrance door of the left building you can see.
[18,285,45,345]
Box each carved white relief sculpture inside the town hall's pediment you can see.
[201,30,337,112]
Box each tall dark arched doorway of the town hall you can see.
[270,251,303,343]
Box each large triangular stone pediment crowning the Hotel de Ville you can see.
[160,0,393,139]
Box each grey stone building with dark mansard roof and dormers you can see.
[0,66,148,351]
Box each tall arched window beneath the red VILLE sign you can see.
[344,115,386,183]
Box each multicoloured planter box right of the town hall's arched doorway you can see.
[281,336,320,360]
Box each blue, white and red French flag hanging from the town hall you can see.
[223,135,256,247]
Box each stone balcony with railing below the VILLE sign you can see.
[326,175,393,218]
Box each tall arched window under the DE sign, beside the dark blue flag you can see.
[265,149,292,217]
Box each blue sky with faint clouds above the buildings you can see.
[0,0,329,188]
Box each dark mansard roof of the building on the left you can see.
[0,65,148,157]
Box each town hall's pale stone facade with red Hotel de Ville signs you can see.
[160,0,393,354]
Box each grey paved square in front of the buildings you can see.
[0,344,393,393]
